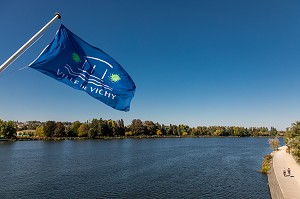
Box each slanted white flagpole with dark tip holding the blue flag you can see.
[0,12,61,73]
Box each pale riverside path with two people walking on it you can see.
[272,146,300,199]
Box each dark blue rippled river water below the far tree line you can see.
[0,138,271,199]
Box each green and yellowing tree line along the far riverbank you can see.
[0,118,283,139]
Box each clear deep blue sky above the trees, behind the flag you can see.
[0,0,300,129]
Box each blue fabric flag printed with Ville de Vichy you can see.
[29,25,136,111]
